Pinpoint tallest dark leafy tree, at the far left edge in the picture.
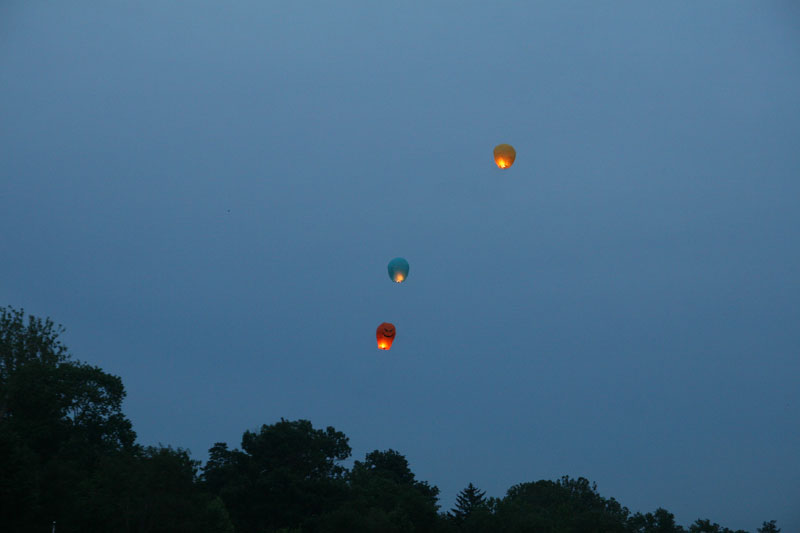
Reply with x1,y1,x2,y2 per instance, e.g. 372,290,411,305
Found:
0,307,136,530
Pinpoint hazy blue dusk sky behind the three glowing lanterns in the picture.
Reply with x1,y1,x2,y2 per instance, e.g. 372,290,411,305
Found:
0,0,800,532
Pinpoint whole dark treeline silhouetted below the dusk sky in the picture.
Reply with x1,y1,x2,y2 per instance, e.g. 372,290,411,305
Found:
0,307,780,533
